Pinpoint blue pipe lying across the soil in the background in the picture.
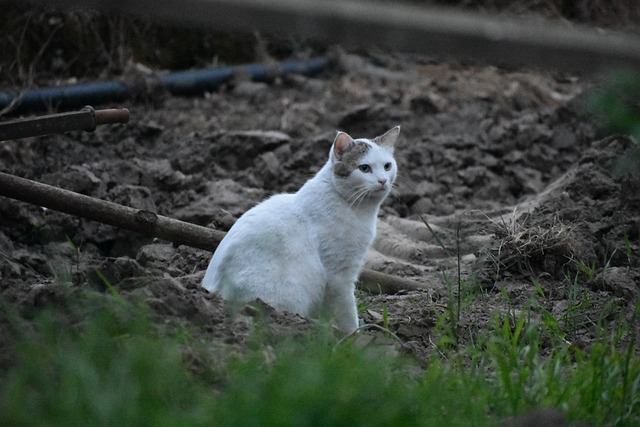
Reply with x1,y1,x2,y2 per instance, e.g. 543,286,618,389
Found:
0,58,327,114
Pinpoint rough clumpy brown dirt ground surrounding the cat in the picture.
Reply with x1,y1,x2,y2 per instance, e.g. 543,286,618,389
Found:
0,47,640,368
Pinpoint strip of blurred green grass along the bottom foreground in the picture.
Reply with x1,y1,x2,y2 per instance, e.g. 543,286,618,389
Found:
0,286,640,426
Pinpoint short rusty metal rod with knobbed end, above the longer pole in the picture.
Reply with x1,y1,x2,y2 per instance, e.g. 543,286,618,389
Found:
0,106,129,141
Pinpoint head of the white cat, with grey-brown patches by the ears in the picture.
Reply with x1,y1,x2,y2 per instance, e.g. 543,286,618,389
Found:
329,126,400,206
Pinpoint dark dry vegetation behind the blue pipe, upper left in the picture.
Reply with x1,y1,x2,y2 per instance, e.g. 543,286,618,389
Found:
0,0,300,88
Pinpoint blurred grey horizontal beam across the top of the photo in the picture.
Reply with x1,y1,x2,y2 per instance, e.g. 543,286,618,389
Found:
47,0,640,72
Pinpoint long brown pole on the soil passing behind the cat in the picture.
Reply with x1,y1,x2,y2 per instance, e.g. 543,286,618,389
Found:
0,172,425,293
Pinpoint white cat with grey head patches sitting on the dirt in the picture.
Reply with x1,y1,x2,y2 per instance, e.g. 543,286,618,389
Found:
202,126,400,332
